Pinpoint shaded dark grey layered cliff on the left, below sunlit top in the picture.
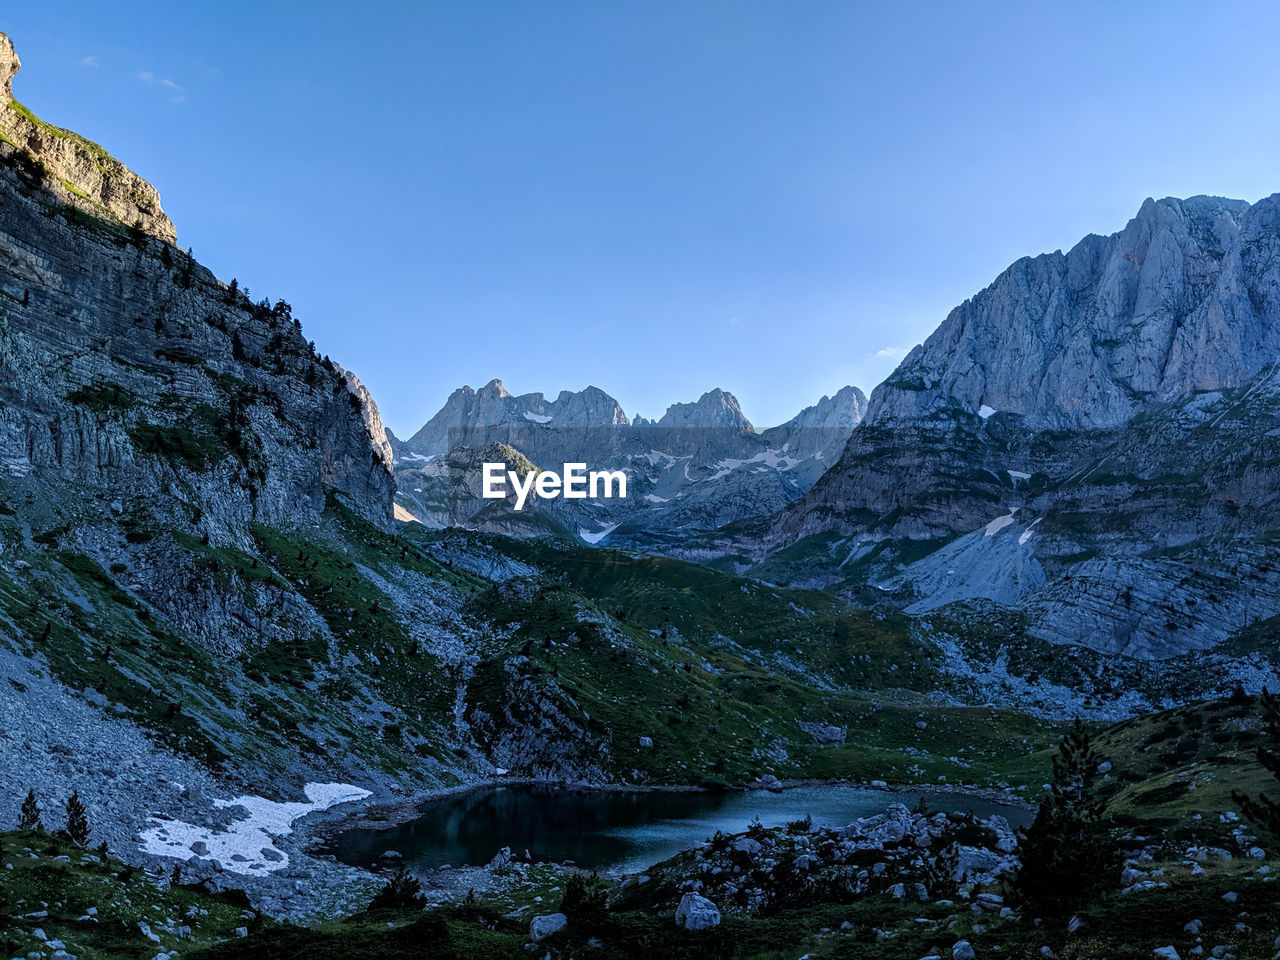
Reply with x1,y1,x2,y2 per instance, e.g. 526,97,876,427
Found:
0,135,393,541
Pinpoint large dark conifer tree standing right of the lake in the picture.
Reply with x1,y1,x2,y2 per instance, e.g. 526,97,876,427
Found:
1012,718,1120,916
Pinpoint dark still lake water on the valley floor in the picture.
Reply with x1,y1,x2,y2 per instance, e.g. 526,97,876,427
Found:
328,785,1032,873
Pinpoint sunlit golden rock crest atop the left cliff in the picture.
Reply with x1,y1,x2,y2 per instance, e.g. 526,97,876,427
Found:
0,33,178,243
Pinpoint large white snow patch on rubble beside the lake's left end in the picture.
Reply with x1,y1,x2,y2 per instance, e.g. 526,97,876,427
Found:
141,783,370,877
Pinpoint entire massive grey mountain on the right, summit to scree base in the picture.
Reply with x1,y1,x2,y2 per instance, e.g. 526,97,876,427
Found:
732,197,1280,658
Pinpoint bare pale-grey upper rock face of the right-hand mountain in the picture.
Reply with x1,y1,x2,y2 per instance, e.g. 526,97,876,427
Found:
867,197,1280,429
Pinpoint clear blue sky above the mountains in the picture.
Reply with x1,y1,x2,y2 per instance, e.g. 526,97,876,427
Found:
0,0,1280,435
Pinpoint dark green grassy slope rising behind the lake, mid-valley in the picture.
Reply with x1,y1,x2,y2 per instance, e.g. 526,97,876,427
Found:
413,534,1056,785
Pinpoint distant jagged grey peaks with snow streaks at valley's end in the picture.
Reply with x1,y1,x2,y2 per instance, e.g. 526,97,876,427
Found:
394,380,867,552
